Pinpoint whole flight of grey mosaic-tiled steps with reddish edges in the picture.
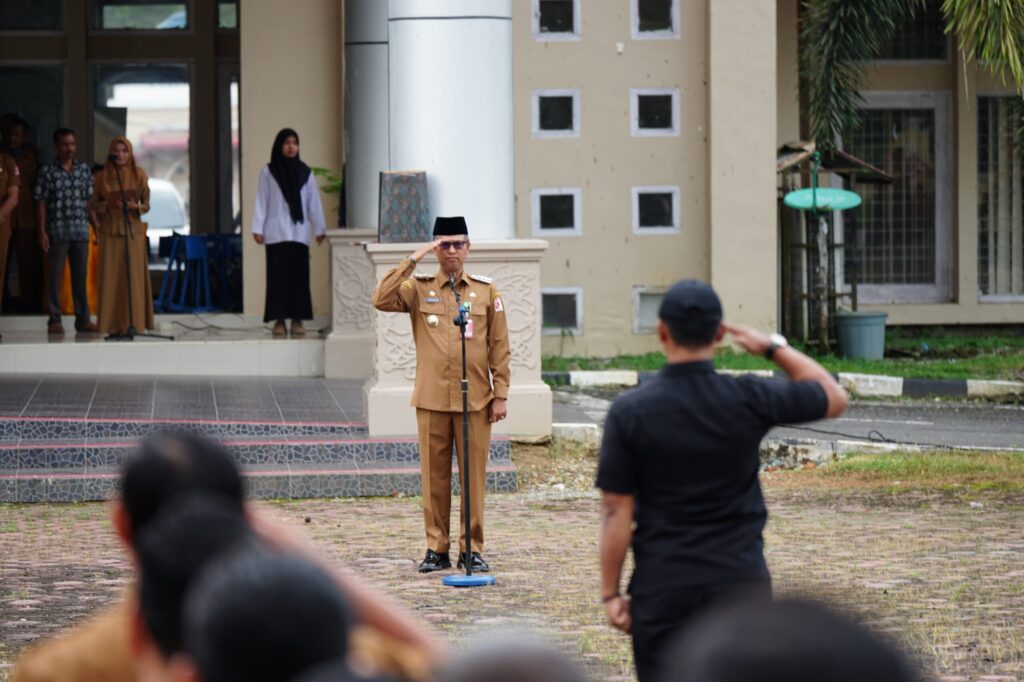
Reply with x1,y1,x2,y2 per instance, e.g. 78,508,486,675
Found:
0,417,516,503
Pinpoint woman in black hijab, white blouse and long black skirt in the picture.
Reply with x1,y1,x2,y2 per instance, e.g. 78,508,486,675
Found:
253,128,325,337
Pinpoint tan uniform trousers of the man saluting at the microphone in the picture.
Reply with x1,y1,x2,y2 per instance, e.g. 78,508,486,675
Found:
416,408,490,554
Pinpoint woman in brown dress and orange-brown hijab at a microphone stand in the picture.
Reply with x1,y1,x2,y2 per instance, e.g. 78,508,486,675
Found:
91,136,154,335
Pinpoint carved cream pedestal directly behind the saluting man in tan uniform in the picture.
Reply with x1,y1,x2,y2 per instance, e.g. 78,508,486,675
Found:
362,240,551,437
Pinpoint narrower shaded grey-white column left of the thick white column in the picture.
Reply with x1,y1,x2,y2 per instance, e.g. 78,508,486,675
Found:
345,0,390,230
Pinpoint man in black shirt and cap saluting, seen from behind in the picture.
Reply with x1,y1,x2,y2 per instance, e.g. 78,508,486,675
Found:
597,280,848,682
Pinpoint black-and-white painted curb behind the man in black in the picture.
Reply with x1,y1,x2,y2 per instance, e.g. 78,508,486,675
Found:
543,370,1024,398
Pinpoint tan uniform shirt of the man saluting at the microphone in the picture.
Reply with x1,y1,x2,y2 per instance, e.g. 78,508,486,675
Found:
374,258,511,412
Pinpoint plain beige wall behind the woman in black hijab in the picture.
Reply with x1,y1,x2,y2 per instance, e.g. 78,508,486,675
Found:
240,0,344,315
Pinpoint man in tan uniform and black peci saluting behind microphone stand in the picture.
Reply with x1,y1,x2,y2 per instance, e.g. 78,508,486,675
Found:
374,216,511,572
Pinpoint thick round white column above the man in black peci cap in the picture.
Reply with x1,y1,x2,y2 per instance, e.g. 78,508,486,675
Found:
387,0,515,238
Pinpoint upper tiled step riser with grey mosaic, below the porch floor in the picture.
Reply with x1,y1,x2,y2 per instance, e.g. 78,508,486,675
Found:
0,417,367,446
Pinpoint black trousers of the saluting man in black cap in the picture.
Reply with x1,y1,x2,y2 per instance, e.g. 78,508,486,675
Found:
630,581,771,682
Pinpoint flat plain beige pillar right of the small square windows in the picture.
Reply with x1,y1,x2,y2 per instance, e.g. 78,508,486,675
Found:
708,0,778,330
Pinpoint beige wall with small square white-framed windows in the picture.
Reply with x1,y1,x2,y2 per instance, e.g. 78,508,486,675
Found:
513,0,709,355
